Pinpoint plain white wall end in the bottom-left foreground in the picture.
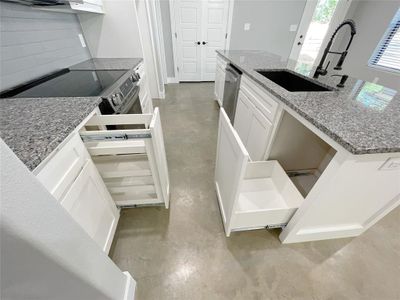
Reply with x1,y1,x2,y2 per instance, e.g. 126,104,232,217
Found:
0,139,134,300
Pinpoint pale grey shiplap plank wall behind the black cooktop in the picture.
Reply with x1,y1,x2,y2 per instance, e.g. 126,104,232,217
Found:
0,2,90,90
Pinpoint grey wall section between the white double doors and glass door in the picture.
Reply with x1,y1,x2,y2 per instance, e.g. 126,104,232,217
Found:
230,0,306,58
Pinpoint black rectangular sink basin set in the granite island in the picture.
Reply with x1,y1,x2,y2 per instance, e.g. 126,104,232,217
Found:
256,70,333,92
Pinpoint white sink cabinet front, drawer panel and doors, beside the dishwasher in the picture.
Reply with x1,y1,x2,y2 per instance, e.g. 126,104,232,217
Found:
234,76,278,160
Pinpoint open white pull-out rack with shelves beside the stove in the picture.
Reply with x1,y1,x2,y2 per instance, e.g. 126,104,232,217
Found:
80,108,169,208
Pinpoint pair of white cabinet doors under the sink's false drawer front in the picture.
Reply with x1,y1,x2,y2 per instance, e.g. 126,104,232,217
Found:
234,91,273,160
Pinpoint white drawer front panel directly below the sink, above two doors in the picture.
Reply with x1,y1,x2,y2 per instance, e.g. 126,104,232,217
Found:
240,75,279,123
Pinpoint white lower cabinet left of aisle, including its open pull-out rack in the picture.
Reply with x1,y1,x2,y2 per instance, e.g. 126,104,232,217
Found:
34,108,170,253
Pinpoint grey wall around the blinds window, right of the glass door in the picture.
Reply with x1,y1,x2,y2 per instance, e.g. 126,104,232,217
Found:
341,0,400,89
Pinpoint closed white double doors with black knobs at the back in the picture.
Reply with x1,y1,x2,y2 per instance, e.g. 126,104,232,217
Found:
170,0,230,81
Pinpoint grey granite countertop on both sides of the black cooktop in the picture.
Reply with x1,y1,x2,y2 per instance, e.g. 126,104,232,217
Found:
0,58,142,171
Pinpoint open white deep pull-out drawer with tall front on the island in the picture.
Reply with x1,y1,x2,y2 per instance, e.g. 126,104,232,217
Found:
215,108,304,236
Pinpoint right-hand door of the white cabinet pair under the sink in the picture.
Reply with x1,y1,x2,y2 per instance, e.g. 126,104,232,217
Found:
245,107,272,161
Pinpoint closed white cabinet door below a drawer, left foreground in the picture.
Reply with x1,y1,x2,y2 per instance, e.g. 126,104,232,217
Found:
61,160,119,252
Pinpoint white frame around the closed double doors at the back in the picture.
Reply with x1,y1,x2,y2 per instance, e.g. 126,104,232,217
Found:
168,0,235,83
